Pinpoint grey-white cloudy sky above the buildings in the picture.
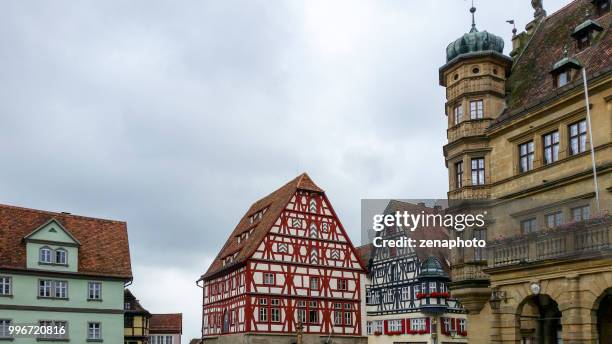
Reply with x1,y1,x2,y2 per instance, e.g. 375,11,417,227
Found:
0,0,568,338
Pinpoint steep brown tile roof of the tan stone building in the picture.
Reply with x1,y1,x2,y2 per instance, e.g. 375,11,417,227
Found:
497,0,612,122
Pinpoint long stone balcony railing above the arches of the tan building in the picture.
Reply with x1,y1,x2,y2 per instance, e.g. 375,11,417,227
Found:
488,216,612,268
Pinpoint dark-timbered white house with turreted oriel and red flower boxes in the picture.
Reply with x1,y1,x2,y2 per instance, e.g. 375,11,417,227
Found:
358,200,467,344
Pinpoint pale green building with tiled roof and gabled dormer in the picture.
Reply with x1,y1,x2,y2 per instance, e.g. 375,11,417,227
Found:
0,205,132,344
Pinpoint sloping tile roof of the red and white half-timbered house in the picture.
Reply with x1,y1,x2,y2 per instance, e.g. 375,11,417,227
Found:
202,173,324,279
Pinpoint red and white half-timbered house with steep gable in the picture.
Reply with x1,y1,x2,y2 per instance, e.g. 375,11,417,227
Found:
198,174,366,343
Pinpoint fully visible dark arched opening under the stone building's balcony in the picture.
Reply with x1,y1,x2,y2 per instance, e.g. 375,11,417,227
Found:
517,294,562,344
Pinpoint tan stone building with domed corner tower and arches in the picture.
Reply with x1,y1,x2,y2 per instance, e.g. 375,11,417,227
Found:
440,0,612,343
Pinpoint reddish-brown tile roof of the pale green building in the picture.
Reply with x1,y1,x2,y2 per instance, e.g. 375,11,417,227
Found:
0,205,132,280
